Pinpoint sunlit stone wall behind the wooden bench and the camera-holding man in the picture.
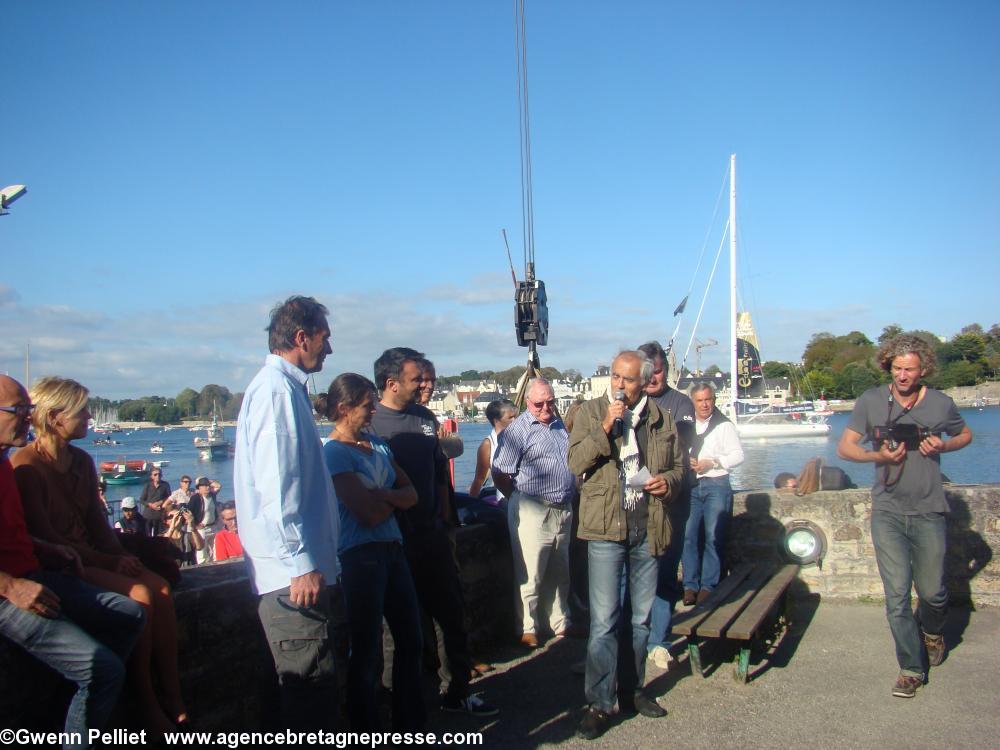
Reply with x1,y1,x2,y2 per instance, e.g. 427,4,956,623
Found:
727,485,1000,606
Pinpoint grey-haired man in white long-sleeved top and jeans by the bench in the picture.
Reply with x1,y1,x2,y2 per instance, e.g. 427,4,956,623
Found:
681,383,743,605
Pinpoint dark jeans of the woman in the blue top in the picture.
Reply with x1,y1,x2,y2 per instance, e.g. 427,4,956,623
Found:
340,542,427,732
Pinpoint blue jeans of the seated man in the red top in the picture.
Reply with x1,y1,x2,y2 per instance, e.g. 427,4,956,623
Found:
0,570,145,748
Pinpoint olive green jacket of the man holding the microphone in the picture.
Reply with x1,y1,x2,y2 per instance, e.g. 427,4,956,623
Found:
569,396,683,555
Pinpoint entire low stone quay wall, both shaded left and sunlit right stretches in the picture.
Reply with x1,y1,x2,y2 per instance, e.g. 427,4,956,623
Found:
0,485,1000,731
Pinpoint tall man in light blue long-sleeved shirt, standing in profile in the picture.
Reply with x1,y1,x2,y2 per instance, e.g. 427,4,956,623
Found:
233,297,339,731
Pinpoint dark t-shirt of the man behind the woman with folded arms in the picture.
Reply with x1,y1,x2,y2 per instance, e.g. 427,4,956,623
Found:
372,403,448,537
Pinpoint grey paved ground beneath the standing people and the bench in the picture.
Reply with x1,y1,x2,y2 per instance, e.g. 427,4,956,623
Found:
429,598,1000,750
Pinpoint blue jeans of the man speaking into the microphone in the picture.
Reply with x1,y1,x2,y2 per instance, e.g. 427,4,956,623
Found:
585,534,656,711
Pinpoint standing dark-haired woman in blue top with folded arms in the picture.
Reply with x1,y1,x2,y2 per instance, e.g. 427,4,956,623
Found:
316,373,427,732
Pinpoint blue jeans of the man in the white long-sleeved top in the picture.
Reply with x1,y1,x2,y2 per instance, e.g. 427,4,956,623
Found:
681,475,733,591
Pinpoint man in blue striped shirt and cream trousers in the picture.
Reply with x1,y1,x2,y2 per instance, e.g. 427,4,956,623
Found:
493,378,576,648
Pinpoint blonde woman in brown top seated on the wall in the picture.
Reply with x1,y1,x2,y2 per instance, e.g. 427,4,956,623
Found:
11,378,187,732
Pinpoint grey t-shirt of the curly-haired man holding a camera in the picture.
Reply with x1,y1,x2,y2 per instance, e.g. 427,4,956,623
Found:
847,385,965,516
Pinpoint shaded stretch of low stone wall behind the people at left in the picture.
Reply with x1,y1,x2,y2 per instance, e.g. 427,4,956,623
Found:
0,525,514,731
